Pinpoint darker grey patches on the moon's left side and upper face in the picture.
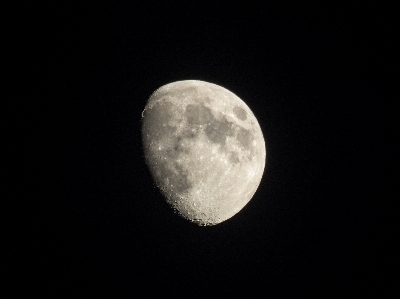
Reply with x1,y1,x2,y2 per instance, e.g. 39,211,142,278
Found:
142,81,264,224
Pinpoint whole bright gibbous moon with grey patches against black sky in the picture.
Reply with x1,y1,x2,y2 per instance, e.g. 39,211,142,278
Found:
141,80,266,226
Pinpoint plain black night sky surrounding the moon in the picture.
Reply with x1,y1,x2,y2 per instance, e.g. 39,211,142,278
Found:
9,1,399,298
